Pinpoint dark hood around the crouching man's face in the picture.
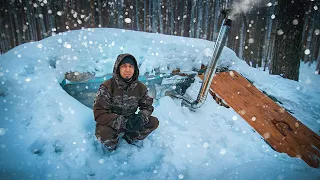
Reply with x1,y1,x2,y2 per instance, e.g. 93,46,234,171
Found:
113,54,139,89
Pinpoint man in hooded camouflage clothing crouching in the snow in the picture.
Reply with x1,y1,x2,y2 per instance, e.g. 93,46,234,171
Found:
93,54,159,150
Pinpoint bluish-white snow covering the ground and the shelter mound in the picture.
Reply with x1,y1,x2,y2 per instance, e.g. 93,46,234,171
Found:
0,29,320,179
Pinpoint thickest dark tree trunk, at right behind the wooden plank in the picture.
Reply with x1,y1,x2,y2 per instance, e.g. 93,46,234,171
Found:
270,0,305,81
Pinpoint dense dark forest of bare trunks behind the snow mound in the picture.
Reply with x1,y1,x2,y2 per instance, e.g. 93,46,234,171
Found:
0,0,320,80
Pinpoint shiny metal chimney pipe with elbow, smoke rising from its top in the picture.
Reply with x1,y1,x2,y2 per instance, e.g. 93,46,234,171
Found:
178,19,232,109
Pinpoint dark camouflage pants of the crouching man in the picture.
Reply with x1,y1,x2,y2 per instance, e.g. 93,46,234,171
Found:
95,116,159,150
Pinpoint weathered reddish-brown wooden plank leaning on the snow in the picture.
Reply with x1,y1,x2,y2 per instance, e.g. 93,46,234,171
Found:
199,71,320,168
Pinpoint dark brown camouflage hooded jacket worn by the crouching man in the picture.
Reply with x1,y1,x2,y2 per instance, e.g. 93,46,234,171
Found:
93,54,154,129
